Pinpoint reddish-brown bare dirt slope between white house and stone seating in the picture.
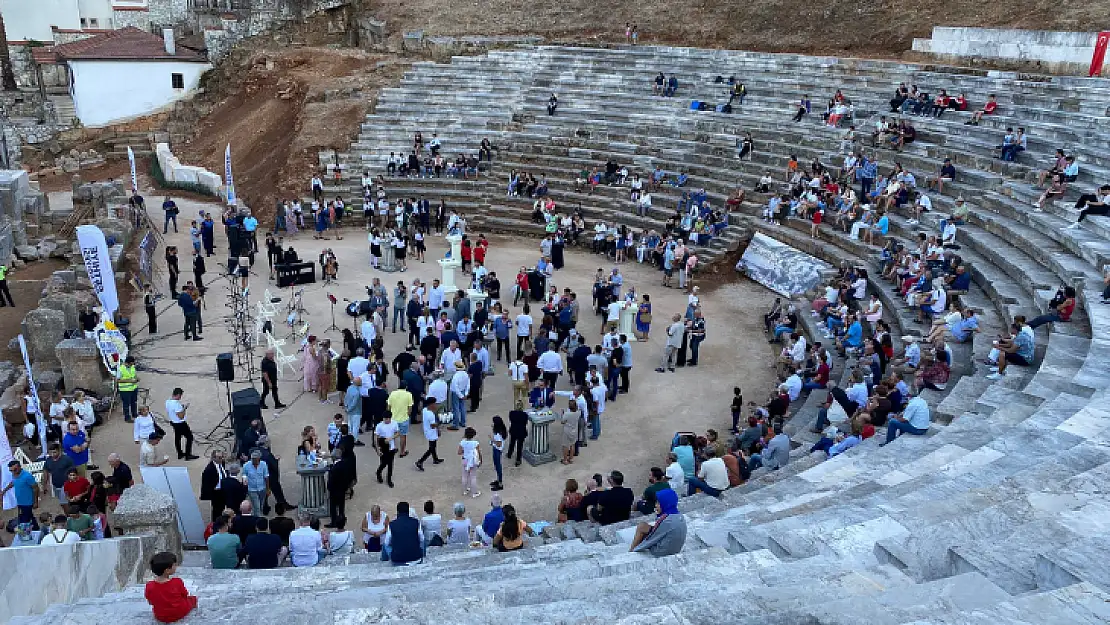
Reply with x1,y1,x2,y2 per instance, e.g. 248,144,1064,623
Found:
170,38,406,215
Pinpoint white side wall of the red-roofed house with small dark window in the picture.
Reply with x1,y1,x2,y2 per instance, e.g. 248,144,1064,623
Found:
69,61,212,127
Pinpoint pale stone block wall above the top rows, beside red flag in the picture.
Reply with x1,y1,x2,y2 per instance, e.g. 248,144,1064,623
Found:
912,27,1110,74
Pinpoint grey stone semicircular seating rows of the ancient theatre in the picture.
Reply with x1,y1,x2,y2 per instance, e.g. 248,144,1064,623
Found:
16,47,1110,625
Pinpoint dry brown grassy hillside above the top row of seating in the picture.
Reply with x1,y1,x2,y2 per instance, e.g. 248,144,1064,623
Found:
367,0,1110,58
